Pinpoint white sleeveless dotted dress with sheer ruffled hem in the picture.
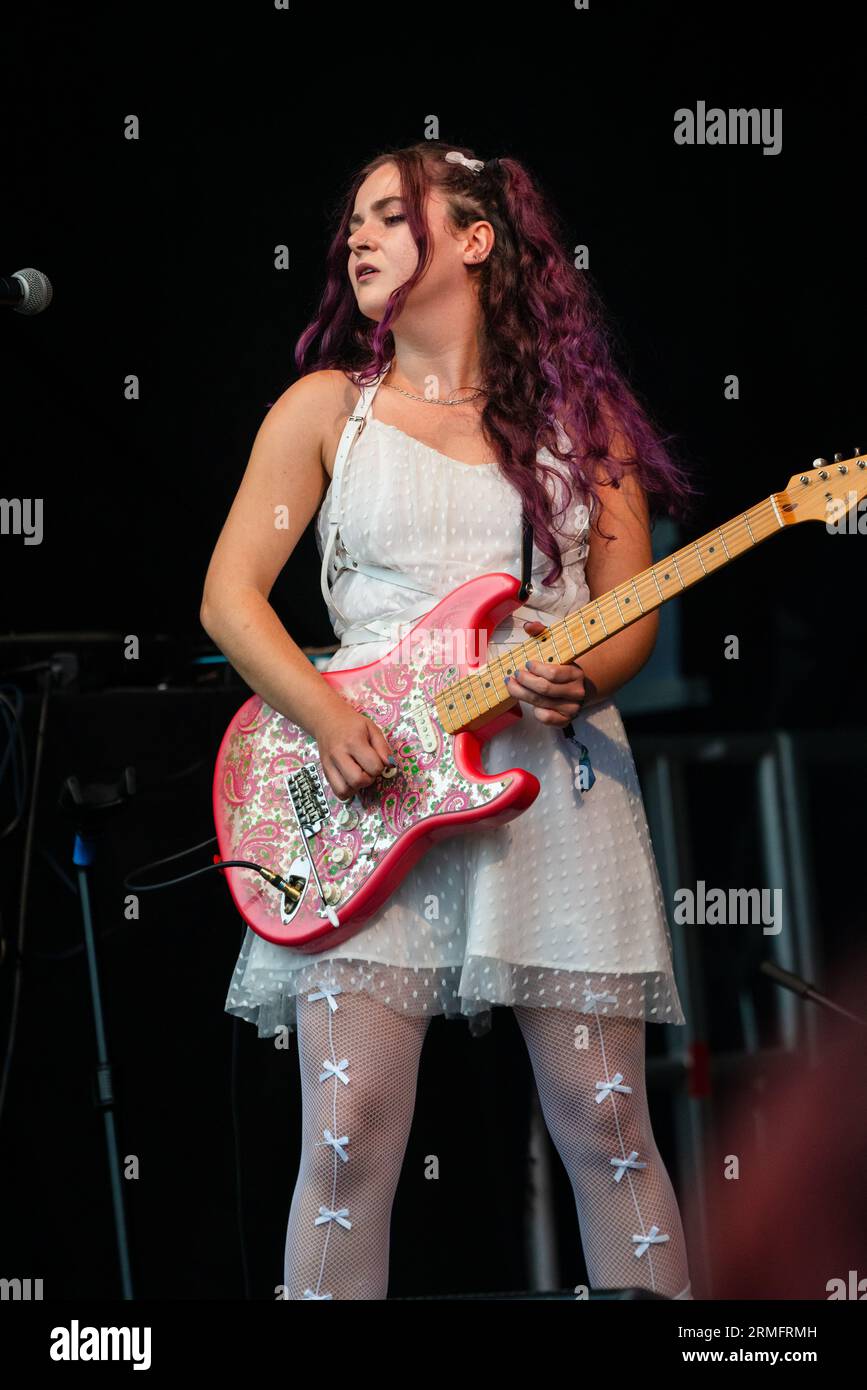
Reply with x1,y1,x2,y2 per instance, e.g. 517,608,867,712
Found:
225,375,686,1037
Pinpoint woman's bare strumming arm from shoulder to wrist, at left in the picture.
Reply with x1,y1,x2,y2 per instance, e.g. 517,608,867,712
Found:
199,373,352,737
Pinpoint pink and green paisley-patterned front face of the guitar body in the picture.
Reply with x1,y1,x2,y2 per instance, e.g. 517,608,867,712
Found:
214,647,513,926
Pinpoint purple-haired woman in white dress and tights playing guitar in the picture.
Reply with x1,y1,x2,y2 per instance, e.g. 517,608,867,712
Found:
201,140,692,1300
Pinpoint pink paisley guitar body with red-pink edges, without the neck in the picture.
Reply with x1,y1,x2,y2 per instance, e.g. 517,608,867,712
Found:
214,574,540,954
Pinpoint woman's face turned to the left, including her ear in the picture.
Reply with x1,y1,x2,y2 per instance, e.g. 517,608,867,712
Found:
347,164,480,322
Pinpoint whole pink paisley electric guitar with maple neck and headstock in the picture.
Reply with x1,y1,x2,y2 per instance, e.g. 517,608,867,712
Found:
214,455,867,954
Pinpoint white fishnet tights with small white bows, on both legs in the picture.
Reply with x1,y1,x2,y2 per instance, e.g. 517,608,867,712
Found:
283,981,691,1300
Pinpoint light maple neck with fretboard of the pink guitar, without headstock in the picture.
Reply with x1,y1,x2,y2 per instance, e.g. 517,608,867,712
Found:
435,495,785,734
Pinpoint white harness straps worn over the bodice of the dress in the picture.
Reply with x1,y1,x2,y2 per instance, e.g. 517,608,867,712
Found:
320,364,539,646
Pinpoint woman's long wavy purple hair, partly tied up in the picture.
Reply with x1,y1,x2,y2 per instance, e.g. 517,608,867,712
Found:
295,140,696,584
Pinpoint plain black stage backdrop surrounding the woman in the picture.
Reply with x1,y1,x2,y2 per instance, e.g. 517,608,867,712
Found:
0,3,867,1298
